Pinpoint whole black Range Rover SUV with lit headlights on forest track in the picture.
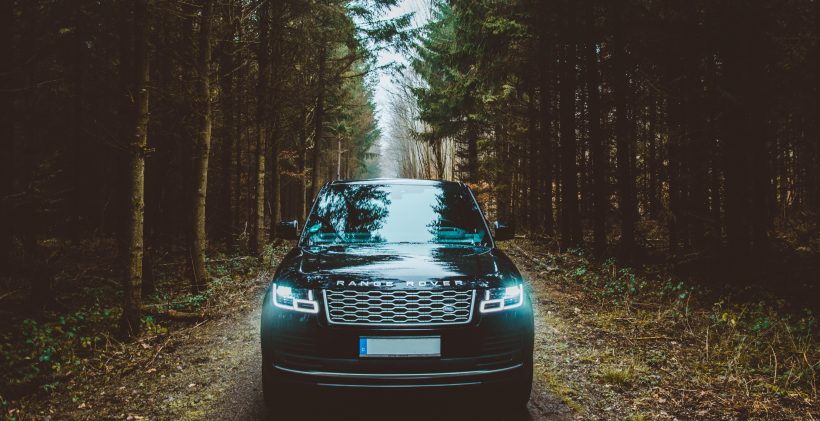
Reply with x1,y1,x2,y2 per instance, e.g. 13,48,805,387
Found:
261,179,533,408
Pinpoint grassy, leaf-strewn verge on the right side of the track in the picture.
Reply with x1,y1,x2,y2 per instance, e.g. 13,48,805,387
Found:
504,239,820,419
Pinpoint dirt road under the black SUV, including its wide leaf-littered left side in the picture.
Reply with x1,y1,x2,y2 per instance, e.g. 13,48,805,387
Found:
22,248,575,421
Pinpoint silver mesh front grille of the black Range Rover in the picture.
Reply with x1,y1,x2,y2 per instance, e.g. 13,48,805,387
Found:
324,290,475,326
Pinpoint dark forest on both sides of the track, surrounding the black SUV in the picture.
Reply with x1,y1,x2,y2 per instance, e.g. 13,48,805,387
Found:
0,0,820,419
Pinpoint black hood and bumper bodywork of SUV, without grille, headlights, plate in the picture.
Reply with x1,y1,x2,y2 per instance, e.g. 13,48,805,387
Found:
261,178,534,400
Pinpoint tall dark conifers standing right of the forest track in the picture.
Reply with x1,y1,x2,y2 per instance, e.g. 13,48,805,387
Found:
404,0,820,260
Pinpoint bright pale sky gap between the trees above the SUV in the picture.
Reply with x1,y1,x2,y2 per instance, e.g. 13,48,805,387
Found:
374,0,431,177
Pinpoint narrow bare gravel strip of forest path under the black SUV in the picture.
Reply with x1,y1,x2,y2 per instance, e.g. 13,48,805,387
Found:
193,251,573,421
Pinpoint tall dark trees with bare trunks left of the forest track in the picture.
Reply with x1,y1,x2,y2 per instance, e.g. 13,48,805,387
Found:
0,0,408,333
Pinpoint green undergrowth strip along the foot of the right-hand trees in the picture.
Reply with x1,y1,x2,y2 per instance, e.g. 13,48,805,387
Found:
556,244,820,412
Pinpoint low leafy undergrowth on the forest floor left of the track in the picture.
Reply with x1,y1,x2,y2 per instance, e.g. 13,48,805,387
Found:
0,241,289,420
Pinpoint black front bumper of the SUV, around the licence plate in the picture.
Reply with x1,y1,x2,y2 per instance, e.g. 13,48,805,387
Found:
261,290,533,388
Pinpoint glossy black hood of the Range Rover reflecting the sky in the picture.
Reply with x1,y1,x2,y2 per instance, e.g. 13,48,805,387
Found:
277,244,520,289
